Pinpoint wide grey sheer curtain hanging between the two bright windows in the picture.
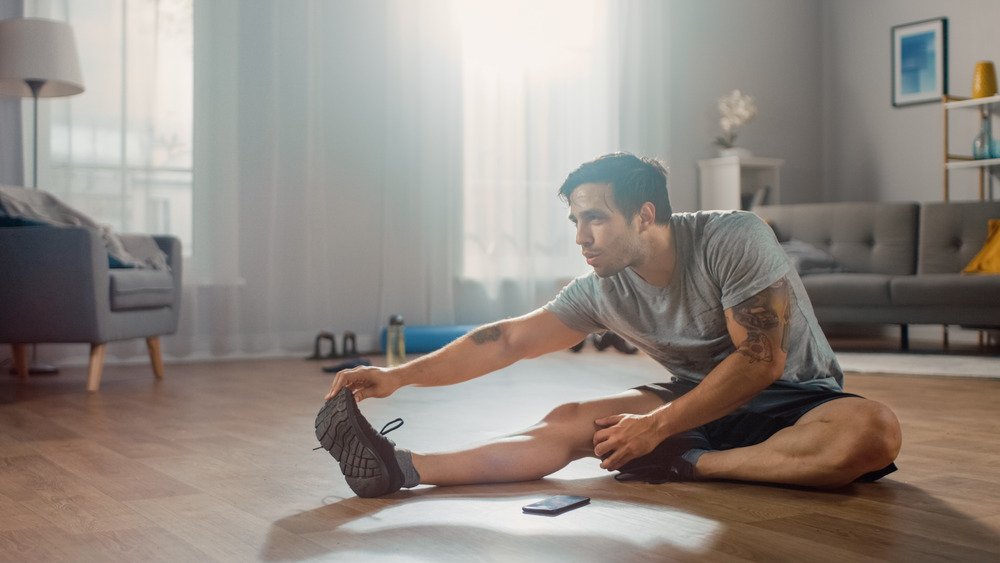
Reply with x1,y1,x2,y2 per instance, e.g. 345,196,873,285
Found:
174,0,461,357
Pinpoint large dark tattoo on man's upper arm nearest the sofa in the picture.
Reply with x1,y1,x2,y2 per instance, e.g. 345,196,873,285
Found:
733,278,793,363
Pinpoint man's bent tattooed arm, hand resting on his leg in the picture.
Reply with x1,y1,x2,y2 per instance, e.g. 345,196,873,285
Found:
594,278,794,470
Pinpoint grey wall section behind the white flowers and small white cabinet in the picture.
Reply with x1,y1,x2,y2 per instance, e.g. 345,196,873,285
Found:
669,0,829,211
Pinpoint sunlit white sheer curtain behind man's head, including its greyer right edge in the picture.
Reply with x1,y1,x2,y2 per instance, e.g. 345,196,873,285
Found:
454,0,668,320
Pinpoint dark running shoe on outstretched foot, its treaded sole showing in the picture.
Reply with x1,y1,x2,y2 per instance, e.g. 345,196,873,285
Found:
316,388,403,497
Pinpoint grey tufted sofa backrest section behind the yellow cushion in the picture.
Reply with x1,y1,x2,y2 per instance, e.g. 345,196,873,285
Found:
917,201,1000,274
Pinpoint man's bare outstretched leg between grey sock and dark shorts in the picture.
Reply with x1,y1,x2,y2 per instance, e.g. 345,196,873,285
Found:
413,389,663,485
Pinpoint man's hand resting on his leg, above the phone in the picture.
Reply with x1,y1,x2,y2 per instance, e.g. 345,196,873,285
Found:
594,414,663,471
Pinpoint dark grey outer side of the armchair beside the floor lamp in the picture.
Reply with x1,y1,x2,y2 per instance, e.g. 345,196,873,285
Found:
0,226,110,343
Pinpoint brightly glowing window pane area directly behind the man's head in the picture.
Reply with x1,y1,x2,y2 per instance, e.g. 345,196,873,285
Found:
455,0,619,288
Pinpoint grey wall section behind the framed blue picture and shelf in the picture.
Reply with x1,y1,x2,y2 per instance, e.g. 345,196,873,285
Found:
820,0,1000,201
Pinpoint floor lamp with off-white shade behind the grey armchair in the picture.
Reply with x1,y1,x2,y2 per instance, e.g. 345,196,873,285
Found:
0,18,83,374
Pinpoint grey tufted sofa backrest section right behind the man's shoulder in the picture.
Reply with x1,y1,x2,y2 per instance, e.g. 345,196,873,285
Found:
753,202,918,275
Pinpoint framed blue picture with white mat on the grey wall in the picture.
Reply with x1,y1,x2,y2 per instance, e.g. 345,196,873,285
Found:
892,18,948,107
